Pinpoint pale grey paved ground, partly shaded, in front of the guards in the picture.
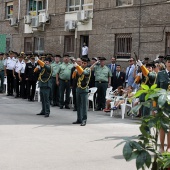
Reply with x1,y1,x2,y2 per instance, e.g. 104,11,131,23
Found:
0,94,138,170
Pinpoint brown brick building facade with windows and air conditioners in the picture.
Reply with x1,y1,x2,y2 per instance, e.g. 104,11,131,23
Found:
0,0,170,61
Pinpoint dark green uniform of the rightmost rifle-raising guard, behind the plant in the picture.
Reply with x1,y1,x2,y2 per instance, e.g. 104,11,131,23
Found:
139,72,156,116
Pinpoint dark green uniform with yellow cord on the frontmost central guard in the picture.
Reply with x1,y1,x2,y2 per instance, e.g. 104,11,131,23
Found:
76,68,91,123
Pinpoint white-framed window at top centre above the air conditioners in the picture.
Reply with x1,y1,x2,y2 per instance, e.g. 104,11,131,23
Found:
67,0,93,12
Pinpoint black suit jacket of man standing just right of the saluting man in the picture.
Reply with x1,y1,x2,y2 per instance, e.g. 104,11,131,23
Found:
111,72,125,90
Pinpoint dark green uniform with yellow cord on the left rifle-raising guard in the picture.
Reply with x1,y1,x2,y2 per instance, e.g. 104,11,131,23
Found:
38,65,52,116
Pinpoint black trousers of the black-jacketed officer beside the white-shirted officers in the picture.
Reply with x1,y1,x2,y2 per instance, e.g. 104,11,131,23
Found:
27,80,36,100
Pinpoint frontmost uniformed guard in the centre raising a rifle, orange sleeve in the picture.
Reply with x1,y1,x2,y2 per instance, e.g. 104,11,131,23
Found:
73,58,91,126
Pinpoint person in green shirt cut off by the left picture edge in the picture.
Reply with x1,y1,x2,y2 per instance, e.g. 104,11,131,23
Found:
0,53,4,93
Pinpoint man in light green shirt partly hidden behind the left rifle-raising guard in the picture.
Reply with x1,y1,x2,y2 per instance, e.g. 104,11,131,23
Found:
51,55,61,107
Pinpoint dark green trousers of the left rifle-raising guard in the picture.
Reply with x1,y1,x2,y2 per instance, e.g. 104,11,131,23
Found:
40,87,51,115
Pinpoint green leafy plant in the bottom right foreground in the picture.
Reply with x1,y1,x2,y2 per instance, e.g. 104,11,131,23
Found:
116,84,170,170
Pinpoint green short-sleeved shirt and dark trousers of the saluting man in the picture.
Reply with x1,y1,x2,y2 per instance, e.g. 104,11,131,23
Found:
94,65,112,110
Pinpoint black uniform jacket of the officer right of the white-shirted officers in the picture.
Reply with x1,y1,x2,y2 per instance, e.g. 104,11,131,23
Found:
25,62,38,81
